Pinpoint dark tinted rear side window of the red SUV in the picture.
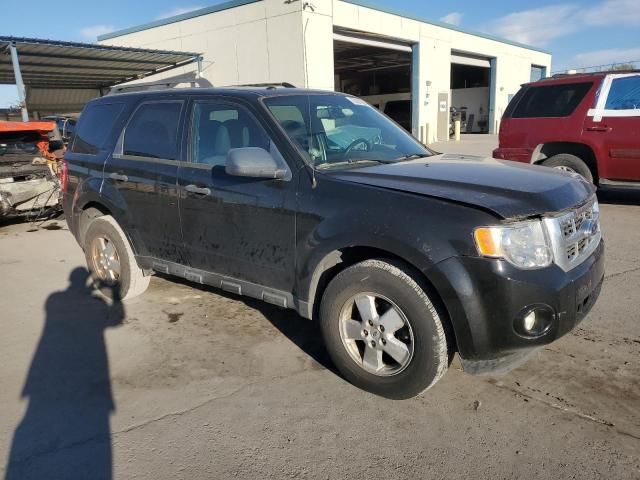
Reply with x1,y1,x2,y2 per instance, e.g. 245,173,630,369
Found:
511,82,593,118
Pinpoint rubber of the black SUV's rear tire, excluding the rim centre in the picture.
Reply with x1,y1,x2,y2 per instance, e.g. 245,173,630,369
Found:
84,215,151,300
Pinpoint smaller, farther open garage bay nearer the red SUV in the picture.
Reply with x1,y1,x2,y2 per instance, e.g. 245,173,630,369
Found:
451,53,491,133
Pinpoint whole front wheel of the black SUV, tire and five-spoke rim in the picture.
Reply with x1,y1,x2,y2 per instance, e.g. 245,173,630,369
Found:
320,260,449,399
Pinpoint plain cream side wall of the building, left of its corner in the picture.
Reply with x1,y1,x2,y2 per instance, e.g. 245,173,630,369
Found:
100,0,308,85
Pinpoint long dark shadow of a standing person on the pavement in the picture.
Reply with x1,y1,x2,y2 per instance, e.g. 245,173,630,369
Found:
5,268,125,480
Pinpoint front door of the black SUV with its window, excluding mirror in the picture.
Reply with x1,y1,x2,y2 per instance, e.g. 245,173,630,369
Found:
178,99,296,292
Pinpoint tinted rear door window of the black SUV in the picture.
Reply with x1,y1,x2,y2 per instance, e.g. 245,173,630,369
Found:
122,101,182,160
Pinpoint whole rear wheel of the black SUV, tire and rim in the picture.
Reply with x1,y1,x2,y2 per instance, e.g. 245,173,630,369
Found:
84,215,151,300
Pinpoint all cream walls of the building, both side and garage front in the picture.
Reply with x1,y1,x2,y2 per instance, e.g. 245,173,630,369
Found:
101,0,551,143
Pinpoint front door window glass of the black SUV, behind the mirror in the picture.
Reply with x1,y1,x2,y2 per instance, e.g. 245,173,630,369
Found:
191,102,270,166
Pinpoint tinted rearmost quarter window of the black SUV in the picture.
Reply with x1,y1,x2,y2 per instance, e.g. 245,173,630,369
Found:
71,103,124,155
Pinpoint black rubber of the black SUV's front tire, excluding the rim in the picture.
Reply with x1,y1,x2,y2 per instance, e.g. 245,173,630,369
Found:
320,259,449,399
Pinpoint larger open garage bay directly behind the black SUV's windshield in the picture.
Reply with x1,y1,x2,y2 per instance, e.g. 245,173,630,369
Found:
333,33,413,132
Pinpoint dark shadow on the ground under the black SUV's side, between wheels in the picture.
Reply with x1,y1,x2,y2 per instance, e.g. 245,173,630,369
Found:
161,274,339,376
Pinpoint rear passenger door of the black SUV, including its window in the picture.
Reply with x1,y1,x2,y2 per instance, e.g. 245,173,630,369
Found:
103,96,186,263
